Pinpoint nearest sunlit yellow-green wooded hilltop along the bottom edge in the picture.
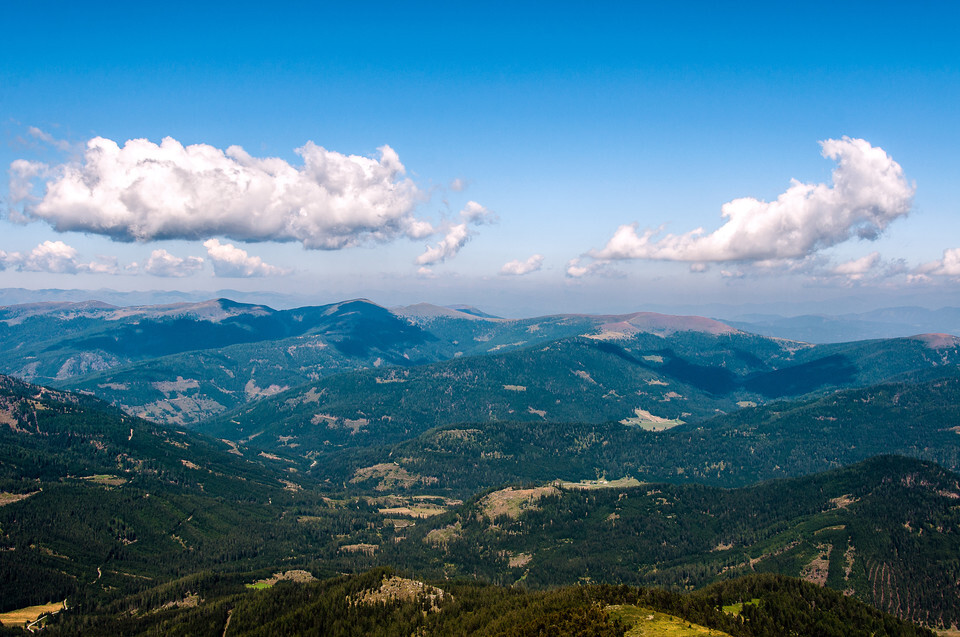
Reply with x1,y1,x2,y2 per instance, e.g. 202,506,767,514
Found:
35,569,934,637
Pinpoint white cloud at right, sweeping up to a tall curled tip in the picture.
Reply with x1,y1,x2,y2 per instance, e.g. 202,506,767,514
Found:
588,137,915,263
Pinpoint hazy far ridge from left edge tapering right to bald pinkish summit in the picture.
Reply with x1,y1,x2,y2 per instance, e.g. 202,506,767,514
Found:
0,299,756,423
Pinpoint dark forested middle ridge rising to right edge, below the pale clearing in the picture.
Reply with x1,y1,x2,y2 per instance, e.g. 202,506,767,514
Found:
324,370,960,497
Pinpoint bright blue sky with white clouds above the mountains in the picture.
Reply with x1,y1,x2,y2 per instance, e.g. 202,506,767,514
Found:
0,2,960,314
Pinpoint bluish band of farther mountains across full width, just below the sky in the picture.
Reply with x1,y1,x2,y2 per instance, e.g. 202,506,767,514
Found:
0,298,960,433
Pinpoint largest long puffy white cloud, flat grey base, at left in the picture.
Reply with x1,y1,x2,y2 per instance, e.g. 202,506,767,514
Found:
10,131,432,250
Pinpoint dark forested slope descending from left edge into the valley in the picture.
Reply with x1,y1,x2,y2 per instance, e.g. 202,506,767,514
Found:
0,377,358,612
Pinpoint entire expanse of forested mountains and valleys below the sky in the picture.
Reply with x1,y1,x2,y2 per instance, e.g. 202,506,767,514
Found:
0,299,960,635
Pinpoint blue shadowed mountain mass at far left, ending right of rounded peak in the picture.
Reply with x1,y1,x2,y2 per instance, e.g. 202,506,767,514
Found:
0,299,446,424
